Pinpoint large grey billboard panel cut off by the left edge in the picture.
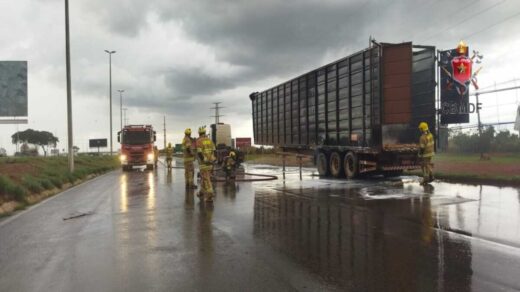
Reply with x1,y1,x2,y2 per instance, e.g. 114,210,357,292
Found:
0,61,27,118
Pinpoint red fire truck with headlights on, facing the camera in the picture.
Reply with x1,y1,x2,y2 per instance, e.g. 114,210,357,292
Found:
117,125,156,171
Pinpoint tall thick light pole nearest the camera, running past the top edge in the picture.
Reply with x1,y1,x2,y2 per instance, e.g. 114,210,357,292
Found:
65,0,74,172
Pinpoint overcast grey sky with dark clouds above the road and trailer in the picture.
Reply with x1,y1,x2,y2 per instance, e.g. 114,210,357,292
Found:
0,0,520,152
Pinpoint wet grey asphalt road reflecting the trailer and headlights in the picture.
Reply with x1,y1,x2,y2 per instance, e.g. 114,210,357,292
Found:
0,159,520,291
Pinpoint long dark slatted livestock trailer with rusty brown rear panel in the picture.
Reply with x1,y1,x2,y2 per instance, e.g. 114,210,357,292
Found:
249,41,436,178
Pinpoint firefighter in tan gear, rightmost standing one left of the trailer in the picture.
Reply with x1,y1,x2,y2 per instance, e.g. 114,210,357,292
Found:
197,127,215,202
